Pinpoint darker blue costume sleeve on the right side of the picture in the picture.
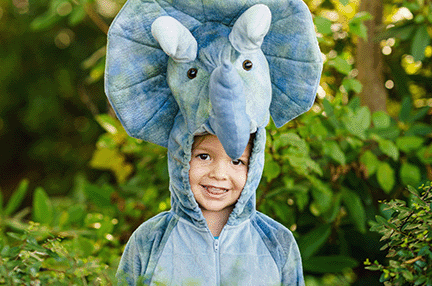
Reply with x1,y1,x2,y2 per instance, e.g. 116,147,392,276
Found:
251,212,304,285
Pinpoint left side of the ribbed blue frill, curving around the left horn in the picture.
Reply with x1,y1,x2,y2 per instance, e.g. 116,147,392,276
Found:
105,1,199,147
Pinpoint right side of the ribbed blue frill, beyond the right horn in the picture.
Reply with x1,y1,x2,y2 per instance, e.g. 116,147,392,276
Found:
261,0,323,127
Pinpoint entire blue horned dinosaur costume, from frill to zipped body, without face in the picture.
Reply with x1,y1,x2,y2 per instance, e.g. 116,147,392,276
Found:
105,0,322,285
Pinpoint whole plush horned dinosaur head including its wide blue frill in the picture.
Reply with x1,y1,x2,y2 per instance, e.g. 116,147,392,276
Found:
105,0,322,158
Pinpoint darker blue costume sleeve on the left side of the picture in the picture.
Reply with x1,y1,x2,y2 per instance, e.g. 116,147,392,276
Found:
116,212,178,285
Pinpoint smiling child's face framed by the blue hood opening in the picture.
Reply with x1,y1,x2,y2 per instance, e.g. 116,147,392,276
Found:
189,135,251,212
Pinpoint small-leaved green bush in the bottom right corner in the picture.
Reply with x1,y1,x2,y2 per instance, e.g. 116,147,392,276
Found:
365,183,432,285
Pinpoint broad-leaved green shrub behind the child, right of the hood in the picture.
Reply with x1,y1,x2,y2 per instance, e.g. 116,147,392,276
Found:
258,96,432,280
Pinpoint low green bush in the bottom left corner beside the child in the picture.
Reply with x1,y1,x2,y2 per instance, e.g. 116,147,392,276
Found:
0,178,125,285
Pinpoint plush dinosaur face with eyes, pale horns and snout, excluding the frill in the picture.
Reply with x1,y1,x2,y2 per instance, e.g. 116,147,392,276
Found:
152,4,272,159
